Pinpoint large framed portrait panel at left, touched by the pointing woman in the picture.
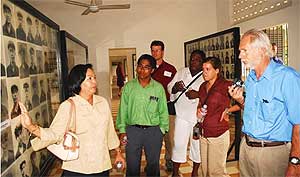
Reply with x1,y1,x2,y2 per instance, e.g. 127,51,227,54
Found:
1,0,62,176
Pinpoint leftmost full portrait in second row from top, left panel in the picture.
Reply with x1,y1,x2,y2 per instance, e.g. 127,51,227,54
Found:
6,41,19,77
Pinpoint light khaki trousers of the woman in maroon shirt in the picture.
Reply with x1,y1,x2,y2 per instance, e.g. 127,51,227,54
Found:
200,130,230,177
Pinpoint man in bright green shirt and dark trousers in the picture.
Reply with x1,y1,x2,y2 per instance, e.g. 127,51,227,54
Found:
117,54,169,176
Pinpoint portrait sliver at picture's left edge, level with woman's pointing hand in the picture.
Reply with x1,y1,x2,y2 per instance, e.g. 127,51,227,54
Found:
0,79,9,122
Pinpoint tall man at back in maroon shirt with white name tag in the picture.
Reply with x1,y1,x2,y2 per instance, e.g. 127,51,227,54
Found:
150,40,177,171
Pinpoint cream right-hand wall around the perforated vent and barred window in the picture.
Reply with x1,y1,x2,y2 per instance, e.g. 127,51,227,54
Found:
217,0,300,71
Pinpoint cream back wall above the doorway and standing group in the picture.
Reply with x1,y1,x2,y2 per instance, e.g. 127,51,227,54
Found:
91,0,216,100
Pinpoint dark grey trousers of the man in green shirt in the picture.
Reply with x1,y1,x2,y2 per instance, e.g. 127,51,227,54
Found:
126,126,163,176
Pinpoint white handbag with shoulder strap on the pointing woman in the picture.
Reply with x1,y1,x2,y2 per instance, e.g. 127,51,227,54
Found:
47,98,79,161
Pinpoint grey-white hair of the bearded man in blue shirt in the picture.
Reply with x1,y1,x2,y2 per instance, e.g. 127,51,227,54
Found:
242,29,273,57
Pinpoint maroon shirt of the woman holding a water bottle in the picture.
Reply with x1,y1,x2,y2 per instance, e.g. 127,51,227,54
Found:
199,77,232,137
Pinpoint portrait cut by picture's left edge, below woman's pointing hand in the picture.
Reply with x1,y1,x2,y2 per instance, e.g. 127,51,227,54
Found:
1,126,14,172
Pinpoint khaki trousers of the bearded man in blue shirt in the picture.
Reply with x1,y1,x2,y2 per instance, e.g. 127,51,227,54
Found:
239,137,291,177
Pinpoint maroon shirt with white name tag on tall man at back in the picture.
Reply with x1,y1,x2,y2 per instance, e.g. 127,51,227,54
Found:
152,61,177,101
